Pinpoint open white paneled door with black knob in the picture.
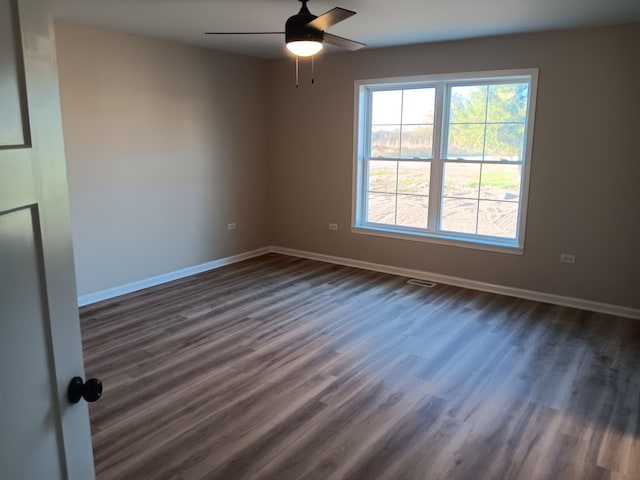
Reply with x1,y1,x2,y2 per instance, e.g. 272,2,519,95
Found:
0,0,95,480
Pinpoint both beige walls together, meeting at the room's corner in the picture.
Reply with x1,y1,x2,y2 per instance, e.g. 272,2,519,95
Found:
57,24,640,308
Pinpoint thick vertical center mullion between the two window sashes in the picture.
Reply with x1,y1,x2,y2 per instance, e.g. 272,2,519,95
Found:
427,83,447,232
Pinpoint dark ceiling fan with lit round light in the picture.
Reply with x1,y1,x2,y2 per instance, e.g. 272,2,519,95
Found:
205,0,366,57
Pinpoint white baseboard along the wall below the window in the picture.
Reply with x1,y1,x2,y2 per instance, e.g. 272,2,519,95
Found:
270,246,640,319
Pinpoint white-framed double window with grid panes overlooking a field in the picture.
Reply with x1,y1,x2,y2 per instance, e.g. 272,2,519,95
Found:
353,70,537,253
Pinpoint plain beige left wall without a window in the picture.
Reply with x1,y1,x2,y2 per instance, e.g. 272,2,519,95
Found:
56,24,269,295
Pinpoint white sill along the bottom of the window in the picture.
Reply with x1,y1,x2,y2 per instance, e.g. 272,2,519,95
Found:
351,225,524,255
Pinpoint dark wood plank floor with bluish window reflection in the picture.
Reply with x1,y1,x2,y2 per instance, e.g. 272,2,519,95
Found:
81,254,640,480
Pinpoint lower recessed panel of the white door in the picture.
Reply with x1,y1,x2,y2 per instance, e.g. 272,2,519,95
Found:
0,208,63,480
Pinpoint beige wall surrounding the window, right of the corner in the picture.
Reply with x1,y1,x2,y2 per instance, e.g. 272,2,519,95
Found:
269,24,640,308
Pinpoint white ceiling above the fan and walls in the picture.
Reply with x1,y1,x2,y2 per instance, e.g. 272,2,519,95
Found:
53,0,640,58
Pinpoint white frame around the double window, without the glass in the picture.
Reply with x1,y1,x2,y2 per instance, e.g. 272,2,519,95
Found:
351,68,538,255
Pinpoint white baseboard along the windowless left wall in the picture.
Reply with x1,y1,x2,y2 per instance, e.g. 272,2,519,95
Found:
78,247,272,307
